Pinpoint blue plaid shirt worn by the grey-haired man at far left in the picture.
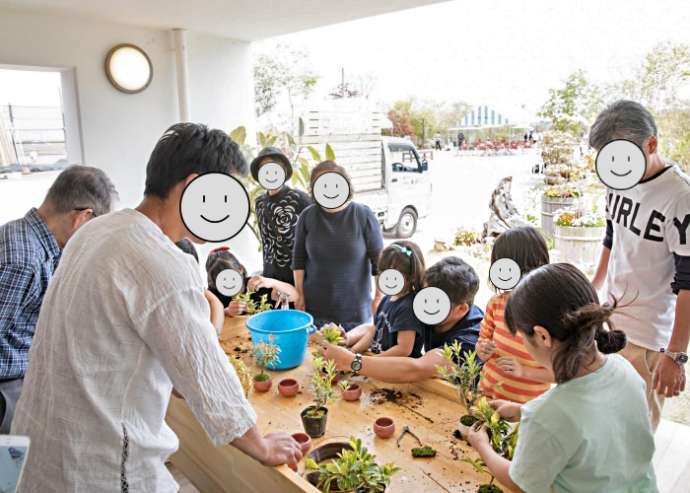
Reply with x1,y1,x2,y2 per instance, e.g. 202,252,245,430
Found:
0,208,60,380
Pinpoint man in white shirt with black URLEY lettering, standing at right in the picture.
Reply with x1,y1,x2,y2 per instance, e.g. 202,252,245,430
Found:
589,101,690,429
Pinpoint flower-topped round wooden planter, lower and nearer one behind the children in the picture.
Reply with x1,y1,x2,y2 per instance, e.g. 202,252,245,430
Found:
554,208,606,271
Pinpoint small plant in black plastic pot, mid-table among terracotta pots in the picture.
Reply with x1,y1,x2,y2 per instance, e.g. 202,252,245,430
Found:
301,356,348,438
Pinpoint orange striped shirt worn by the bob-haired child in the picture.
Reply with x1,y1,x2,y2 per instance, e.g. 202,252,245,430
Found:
479,293,551,403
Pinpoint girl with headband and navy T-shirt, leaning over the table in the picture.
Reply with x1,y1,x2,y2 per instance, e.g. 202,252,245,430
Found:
345,241,425,358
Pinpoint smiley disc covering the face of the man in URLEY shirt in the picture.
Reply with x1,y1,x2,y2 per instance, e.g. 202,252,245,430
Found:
596,139,647,190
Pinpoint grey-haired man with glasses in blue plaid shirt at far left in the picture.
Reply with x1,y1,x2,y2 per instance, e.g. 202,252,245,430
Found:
0,166,117,433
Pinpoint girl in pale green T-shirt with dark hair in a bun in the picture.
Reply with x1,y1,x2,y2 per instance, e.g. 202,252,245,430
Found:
465,264,658,493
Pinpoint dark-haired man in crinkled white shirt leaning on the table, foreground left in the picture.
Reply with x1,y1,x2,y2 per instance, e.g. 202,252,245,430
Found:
12,123,301,493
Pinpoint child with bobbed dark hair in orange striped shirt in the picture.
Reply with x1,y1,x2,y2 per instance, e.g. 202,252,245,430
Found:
477,226,553,402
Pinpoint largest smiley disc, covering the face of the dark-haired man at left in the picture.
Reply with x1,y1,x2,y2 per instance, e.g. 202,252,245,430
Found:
180,173,249,242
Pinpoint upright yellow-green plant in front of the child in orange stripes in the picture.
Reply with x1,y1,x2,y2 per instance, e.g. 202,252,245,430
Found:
436,341,482,410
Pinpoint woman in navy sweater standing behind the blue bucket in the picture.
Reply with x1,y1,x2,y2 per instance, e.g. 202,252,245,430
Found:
292,161,383,330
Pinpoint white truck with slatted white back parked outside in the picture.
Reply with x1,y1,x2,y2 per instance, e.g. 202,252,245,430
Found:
302,105,431,238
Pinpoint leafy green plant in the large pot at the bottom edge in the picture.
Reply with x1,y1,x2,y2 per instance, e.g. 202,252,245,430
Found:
305,437,400,493
